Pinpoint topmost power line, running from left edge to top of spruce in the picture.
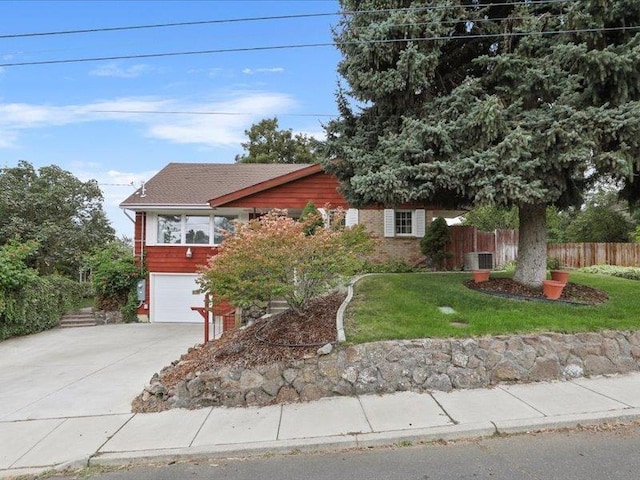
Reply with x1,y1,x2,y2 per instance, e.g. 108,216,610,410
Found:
0,0,573,39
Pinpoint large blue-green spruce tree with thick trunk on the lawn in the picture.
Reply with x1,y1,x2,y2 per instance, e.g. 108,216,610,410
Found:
327,0,640,286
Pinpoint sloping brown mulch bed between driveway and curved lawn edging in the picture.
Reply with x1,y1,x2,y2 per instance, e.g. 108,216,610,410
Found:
160,293,346,388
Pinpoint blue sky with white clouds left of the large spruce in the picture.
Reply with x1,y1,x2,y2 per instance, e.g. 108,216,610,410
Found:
0,0,340,236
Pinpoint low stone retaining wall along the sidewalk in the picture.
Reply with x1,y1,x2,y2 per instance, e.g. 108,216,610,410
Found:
134,331,640,411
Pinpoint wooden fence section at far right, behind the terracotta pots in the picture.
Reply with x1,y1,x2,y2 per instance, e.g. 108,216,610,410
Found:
547,243,640,268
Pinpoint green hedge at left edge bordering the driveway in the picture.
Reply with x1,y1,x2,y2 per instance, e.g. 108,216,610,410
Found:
0,242,82,340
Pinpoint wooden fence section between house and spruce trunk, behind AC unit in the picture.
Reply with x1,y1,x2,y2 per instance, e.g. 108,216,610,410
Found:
446,225,518,269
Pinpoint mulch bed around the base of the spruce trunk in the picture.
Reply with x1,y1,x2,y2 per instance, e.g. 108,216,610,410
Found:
465,278,609,305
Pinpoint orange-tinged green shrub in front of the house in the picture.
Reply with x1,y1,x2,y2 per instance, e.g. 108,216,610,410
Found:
201,211,373,311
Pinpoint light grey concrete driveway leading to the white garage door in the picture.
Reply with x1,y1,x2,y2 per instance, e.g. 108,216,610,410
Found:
0,324,202,422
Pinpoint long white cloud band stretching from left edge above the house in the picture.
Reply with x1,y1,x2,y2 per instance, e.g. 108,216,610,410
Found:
0,92,296,148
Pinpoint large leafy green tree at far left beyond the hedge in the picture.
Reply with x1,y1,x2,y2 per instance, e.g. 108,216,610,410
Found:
0,161,114,278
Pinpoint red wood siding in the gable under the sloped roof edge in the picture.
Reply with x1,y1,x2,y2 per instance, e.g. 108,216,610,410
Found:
224,172,348,208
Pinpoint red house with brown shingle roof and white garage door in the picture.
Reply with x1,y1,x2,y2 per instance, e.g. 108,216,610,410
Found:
120,163,459,322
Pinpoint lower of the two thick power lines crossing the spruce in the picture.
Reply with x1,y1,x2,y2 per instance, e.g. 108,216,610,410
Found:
0,26,640,67
